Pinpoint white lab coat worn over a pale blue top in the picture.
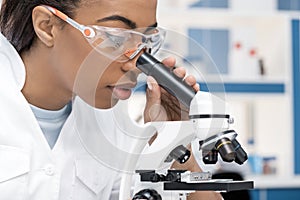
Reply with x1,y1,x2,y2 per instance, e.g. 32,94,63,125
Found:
0,35,139,200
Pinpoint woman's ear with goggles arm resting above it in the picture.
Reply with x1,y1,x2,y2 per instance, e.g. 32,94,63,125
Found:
32,6,57,47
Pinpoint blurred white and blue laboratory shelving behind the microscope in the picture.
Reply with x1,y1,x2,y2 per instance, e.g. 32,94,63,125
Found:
132,0,300,200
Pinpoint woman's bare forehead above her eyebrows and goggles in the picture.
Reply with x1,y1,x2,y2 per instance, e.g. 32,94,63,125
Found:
75,0,157,27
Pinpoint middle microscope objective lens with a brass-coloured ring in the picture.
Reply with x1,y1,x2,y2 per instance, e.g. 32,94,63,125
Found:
215,138,236,162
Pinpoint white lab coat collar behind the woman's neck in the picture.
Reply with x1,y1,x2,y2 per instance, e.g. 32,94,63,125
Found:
0,33,26,91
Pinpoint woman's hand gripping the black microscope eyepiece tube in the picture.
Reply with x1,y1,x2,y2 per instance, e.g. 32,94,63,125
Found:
144,58,199,122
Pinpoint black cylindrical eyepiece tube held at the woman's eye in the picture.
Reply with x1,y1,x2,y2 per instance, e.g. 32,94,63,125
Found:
136,52,196,108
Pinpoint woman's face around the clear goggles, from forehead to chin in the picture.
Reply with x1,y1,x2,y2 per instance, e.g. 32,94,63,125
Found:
51,0,157,108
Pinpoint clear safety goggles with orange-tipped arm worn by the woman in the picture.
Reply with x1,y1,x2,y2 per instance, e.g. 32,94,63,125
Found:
44,5,166,62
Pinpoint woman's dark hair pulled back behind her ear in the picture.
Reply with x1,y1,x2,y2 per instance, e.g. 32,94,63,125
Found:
0,0,80,53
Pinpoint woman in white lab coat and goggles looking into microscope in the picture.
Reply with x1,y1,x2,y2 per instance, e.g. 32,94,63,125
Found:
0,0,220,200
